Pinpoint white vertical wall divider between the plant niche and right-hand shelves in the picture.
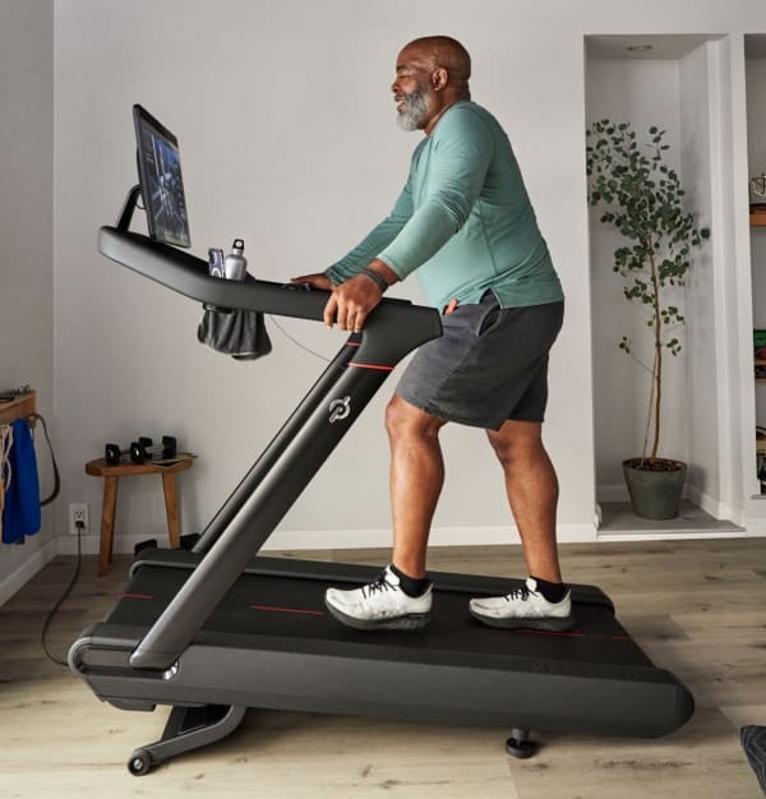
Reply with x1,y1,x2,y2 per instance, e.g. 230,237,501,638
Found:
684,39,755,532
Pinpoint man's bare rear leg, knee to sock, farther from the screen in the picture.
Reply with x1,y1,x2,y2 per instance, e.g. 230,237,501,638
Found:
487,420,561,583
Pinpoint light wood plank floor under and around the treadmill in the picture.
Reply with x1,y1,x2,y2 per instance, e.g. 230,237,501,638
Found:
0,539,766,799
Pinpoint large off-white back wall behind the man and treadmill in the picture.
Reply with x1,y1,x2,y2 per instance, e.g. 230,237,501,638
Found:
54,0,766,546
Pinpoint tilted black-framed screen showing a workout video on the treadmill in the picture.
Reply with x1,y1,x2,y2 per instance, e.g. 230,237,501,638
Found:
133,105,191,247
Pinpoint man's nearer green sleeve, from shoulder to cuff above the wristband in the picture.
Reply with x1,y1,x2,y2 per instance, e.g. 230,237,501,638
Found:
377,108,494,280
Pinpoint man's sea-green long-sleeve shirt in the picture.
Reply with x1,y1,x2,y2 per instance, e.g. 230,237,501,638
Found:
326,100,564,309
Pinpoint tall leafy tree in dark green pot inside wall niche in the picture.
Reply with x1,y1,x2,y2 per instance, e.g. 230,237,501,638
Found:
586,119,710,519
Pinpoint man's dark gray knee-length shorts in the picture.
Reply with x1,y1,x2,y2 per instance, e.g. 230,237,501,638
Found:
396,291,564,430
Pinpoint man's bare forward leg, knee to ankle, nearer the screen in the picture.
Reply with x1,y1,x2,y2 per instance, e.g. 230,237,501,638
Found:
386,394,446,579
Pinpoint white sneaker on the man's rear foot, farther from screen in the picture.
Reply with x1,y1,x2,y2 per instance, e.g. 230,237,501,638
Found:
468,577,575,632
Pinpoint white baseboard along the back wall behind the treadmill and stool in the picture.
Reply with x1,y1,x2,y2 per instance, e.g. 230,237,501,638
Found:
56,524,596,555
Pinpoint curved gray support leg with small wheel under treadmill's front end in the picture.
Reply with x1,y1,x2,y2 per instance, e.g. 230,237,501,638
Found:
128,705,247,777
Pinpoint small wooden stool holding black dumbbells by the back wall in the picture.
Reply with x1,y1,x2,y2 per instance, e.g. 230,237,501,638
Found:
85,458,194,575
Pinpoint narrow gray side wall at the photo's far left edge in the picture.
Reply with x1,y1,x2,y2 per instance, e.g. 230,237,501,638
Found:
0,0,53,604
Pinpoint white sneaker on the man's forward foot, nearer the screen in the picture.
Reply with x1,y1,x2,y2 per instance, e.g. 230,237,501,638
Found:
324,566,433,630
